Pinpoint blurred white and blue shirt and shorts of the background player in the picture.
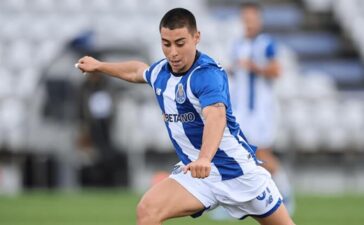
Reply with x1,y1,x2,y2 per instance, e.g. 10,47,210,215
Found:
231,34,277,148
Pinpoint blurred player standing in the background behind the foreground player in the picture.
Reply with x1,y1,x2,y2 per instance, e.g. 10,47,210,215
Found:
231,2,294,213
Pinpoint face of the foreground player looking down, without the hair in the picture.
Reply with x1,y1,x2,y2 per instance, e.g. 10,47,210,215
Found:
161,27,200,73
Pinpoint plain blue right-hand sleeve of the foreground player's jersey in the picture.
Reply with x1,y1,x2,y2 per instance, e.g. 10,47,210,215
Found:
190,67,229,108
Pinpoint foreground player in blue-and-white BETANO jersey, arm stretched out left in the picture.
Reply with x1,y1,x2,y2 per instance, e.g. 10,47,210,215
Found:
78,8,293,225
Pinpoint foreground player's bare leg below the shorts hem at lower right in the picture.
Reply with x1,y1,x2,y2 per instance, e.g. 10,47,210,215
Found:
253,204,294,225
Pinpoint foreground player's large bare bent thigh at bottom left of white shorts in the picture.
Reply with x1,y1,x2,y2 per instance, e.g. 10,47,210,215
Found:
137,178,205,225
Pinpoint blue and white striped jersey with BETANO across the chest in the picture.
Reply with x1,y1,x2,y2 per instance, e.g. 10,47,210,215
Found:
144,52,255,180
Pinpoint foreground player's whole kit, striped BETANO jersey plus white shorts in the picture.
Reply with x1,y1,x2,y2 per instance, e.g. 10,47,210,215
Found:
144,52,281,218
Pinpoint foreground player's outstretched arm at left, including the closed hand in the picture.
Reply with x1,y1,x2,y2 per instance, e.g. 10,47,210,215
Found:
76,56,149,83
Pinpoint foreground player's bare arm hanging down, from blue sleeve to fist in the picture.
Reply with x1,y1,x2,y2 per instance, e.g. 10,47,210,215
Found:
184,103,226,178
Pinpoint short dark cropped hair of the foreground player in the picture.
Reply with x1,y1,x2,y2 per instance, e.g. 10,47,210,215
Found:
159,8,197,34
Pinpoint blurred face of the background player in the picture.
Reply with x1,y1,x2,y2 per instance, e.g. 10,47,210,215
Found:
241,7,262,38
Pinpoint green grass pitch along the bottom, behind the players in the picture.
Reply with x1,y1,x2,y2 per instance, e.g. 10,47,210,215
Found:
0,190,364,225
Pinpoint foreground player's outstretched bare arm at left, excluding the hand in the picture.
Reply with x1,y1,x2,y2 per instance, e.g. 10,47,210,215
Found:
97,61,148,83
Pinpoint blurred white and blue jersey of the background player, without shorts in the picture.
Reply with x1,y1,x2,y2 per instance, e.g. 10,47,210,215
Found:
231,34,277,121
